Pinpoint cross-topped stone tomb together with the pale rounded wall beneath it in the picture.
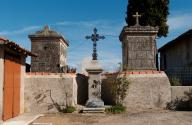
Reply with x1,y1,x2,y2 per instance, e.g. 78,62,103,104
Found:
119,13,171,109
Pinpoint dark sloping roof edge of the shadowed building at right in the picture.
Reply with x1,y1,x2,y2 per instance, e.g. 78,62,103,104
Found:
158,29,192,52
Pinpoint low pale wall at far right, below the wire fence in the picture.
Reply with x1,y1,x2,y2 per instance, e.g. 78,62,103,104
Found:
171,86,192,101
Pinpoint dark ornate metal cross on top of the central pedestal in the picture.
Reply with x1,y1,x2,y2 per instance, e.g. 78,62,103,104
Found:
85,28,105,60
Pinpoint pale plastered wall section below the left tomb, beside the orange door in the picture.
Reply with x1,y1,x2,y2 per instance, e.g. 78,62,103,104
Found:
24,73,77,113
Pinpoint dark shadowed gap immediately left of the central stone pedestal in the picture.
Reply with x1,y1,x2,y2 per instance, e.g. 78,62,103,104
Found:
76,73,88,105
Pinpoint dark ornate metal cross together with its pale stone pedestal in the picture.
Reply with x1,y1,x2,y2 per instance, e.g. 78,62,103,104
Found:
83,28,105,113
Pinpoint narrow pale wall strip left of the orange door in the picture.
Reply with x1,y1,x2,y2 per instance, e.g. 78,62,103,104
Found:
0,47,4,121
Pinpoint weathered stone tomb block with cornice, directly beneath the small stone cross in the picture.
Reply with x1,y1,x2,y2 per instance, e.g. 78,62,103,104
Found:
119,25,159,71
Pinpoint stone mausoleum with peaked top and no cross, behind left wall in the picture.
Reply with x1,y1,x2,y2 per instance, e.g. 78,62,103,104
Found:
29,26,69,73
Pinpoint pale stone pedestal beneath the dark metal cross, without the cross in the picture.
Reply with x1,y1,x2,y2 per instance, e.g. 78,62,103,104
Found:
84,60,104,112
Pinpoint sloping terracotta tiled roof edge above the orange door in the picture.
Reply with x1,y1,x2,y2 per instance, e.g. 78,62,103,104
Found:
0,37,37,56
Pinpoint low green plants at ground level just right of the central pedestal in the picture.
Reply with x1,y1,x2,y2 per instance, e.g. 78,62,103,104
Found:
105,104,126,114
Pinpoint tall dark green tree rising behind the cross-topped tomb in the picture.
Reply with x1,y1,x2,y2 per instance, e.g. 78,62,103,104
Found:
126,0,169,37
